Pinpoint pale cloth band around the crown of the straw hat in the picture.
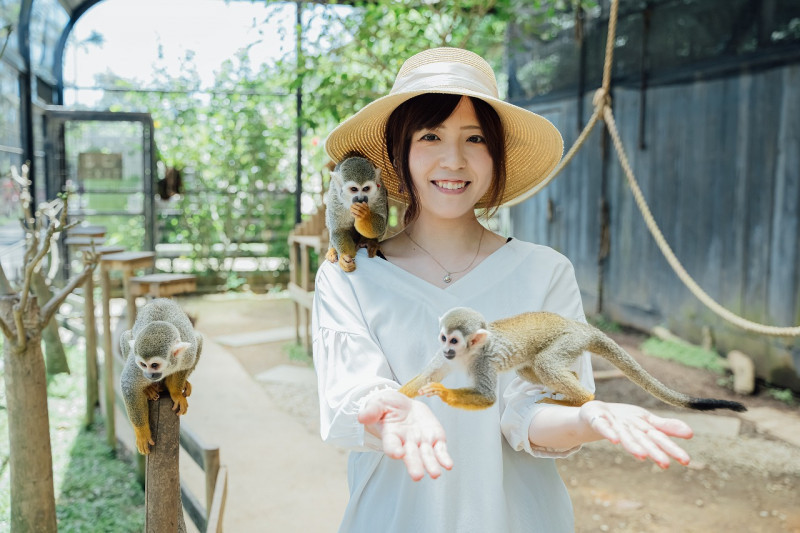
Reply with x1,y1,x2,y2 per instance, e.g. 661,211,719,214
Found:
389,61,498,98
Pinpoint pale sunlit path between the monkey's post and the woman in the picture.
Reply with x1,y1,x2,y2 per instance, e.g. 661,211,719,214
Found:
181,337,347,533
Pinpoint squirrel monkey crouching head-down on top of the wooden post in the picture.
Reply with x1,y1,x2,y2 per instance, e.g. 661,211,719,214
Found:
120,298,203,455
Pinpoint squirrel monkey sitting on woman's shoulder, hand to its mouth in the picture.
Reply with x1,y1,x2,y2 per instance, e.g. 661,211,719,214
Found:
325,153,388,272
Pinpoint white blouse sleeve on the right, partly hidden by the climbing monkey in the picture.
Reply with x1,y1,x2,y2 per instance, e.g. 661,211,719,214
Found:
500,254,595,457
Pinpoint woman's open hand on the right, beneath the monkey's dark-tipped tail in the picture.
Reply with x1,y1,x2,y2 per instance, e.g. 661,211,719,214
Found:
580,400,693,468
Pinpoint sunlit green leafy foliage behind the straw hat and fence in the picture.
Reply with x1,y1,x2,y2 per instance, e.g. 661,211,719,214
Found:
70,0,585,271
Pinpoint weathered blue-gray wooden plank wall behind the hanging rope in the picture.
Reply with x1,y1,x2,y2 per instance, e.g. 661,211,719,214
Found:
511,64,800,390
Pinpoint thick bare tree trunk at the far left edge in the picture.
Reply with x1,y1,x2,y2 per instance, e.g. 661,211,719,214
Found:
0,295,56,533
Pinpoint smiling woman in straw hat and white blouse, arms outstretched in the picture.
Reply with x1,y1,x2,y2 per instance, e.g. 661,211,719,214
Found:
313,48,691,533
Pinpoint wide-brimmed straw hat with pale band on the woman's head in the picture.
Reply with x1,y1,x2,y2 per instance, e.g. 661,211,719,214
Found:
325,48,564,207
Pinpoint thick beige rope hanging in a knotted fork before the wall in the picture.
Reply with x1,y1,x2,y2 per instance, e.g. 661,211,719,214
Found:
508,0,800,337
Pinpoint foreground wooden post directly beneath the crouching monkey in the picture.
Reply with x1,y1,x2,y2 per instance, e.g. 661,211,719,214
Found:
144,394,186,533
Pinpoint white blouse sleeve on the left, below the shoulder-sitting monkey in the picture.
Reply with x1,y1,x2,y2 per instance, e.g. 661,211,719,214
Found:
312,263,400,451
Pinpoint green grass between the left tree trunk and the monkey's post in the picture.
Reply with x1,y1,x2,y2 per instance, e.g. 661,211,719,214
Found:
0,336,144,533
